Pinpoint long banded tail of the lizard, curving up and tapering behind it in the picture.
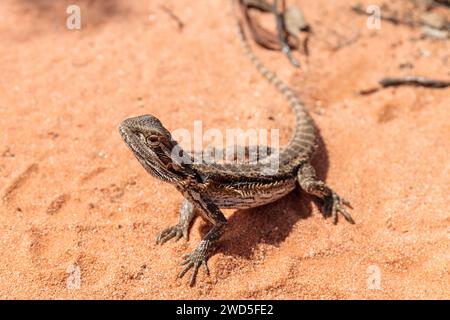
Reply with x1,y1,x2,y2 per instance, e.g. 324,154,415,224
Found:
236,21,317,163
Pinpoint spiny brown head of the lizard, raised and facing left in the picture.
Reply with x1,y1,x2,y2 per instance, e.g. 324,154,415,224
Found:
119,115,190,182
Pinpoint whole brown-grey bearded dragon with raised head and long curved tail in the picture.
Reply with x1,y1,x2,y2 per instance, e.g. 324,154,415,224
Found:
119,13,354,286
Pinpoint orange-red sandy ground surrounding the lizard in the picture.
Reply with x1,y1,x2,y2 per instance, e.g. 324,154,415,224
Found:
0,0,450,299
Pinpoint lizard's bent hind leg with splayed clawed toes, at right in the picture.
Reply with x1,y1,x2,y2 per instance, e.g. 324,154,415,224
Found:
297,164,355,224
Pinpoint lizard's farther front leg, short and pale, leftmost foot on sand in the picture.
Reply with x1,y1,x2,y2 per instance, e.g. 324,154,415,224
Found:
156,199,196,244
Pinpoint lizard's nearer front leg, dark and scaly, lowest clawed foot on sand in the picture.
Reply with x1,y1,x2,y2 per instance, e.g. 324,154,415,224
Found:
178,191,227,286
